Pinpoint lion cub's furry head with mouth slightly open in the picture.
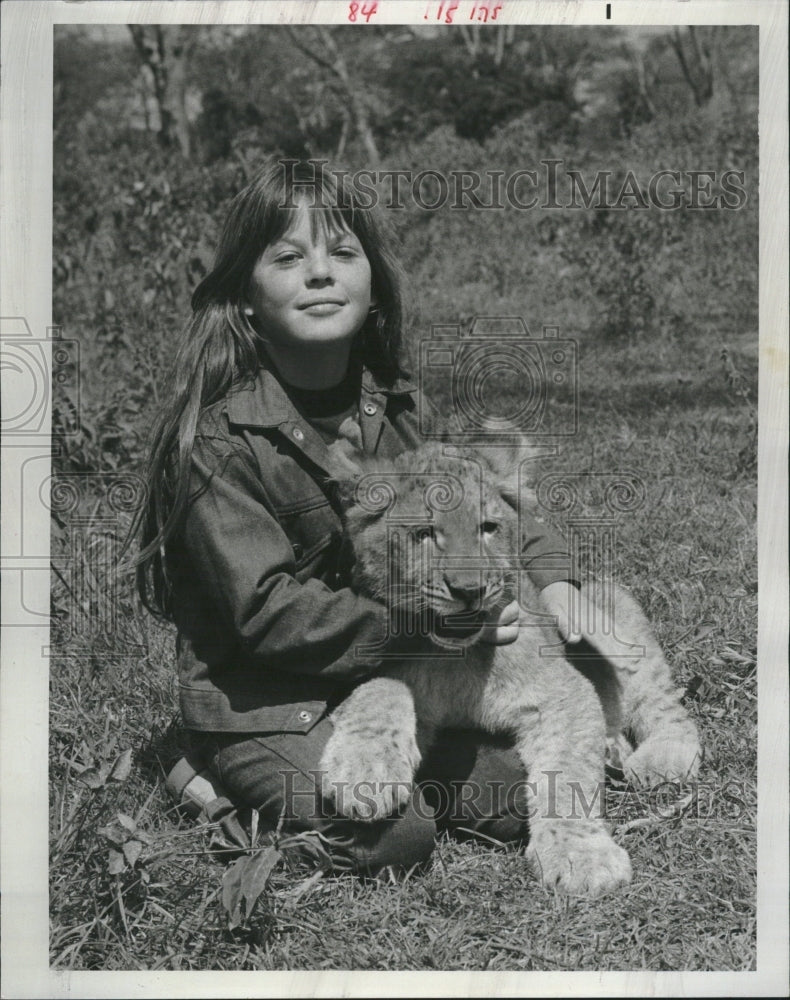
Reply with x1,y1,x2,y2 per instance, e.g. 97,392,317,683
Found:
346,446,518,641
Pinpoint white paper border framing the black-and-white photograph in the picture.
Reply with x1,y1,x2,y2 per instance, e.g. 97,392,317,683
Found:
0,0,790,998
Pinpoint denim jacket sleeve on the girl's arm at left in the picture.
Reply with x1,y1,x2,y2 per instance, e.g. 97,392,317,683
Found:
182,436,387,682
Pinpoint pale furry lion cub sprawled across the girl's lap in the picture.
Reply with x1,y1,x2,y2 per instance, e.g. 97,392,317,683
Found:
321,445,700,895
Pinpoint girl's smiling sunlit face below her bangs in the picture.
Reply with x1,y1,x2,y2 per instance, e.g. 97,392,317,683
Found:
247,204,371,352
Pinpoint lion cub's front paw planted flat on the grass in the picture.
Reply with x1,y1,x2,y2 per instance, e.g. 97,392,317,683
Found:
526,820,631,896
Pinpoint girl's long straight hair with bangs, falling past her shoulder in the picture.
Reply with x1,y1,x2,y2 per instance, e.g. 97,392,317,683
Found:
129,160,404,618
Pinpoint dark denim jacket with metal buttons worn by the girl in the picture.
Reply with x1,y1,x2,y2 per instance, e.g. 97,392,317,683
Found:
173,368,567,732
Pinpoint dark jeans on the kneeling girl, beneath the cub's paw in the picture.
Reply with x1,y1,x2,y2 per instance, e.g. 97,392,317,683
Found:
192,718,528,875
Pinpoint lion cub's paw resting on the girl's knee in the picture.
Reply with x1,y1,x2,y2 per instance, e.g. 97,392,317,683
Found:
320,730,420,823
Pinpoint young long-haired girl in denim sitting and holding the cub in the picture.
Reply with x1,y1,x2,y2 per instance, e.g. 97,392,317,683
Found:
138,161,580,873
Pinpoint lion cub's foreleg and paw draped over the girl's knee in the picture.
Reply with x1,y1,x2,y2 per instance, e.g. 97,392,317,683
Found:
320,677,420,822
